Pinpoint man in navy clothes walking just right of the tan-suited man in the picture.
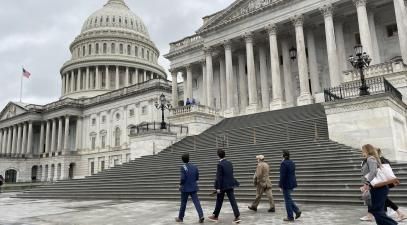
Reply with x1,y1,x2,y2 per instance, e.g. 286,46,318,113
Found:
279,150,301,222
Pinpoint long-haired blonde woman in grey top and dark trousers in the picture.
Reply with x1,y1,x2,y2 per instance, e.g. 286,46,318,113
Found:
360,144,397,225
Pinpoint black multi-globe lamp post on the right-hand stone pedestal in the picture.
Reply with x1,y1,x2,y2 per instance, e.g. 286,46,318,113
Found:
348,45,372,96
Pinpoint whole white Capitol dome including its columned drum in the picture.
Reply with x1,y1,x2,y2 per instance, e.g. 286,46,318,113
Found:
61,0,167,99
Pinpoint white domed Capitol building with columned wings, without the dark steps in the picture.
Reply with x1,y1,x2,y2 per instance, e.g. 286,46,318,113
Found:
0,0,407,182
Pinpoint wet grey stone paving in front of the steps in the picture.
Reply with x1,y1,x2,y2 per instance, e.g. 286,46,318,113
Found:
0,193,407,225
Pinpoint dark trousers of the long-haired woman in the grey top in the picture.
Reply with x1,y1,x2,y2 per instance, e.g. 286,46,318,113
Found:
369,186,397,225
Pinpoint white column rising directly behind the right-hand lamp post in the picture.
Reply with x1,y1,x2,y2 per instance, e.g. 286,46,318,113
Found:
353,0,378,64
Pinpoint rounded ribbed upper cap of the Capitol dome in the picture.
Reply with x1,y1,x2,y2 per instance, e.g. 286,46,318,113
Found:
82,0,150,38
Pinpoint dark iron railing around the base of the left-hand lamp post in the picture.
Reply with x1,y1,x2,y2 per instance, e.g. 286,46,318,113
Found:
128,122,189,136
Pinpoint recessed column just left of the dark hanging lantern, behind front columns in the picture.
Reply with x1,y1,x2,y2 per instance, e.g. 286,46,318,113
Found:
281,37,295,107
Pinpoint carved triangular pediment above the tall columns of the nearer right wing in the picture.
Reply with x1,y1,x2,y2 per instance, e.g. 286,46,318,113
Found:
197,0,290,33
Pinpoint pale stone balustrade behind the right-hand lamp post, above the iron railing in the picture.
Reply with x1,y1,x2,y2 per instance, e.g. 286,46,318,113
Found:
343,61,407,82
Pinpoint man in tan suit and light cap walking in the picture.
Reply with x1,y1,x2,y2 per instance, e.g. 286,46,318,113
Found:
248,155,275,212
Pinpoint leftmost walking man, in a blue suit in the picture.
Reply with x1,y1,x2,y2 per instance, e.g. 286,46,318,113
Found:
175,153,204,223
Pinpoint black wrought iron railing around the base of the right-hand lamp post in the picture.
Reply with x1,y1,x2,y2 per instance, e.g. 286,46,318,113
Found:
324,77,403,102
